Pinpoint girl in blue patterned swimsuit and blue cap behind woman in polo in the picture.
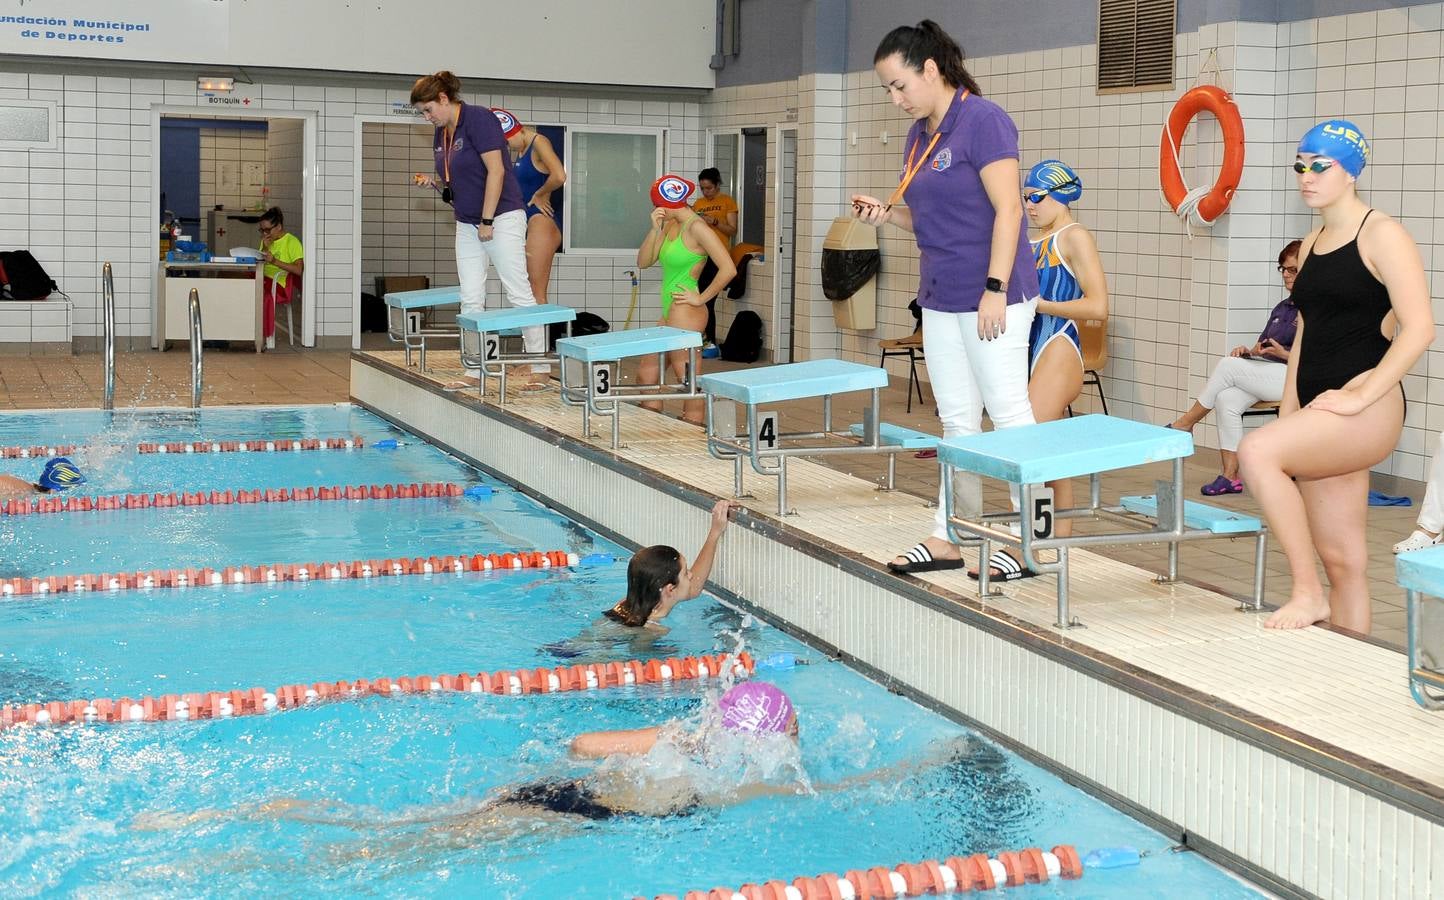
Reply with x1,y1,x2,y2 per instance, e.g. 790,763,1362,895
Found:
969,159,1108,581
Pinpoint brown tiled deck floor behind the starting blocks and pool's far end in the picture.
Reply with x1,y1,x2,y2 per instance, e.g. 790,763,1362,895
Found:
0,339,1422,646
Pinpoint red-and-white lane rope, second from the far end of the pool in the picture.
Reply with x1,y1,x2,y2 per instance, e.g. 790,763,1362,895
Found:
0,481,464,516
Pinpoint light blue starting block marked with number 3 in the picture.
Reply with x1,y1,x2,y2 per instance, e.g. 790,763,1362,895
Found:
556,325,702,449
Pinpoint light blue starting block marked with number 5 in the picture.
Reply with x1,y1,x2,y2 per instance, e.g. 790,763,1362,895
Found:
937,415,1268,628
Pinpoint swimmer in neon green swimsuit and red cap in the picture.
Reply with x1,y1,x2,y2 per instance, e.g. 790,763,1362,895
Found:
637,175,736,425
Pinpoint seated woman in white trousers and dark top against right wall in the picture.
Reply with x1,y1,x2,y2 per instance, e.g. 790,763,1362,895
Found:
1168,241,1302,497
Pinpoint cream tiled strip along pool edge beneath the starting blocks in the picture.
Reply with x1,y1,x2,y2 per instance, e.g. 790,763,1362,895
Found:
358,346,1444,792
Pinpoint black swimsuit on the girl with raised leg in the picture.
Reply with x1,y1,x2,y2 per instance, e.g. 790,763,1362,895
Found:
1294,209,1392,406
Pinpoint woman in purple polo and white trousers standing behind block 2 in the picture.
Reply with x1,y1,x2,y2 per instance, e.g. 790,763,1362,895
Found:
412,72,546,390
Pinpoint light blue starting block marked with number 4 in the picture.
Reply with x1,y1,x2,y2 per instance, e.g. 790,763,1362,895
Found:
699,360,937,516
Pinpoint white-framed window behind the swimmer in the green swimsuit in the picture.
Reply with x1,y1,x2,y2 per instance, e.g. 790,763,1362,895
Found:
566,126,661,253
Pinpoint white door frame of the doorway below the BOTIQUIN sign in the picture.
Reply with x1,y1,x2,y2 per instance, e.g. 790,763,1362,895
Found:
150,103,321,347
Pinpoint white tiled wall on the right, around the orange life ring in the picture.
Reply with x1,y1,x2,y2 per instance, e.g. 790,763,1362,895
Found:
703,4,1444,478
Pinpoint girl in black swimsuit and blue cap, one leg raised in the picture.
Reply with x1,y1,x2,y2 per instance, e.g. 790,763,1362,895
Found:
1239,118,1434,634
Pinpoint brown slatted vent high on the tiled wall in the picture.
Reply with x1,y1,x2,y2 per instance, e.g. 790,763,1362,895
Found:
1097,0,1178,91
